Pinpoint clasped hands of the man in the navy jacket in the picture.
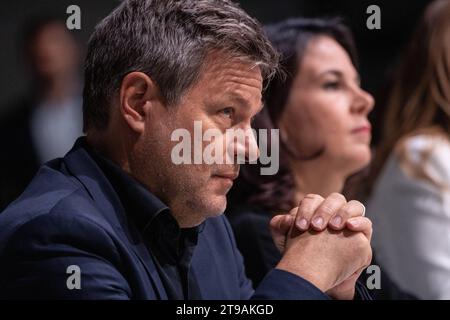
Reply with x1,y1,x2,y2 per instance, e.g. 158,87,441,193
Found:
270,193,372,299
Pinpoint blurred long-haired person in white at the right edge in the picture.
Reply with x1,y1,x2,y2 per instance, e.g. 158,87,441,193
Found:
367,0,450,299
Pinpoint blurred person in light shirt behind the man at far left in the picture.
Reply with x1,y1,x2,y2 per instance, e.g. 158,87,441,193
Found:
0,17,82,210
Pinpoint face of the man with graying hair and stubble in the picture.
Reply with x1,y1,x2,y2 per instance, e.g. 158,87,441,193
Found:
137,53,262,227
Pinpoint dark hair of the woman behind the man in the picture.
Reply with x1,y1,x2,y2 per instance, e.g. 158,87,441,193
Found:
228,18,357,213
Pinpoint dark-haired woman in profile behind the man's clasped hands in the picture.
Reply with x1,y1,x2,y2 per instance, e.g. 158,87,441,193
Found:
229,18,414,298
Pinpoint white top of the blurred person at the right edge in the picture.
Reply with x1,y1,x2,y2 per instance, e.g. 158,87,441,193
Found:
367,135,450,299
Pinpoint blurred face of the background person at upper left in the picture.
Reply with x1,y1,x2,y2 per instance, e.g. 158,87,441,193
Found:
28,22,79,80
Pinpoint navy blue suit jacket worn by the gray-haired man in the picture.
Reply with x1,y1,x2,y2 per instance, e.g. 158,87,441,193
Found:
0,138,327,299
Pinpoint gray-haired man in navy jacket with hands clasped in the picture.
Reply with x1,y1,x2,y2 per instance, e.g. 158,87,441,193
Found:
0,0,371,299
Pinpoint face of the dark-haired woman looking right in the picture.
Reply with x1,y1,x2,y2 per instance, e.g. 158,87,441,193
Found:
279,36,374,174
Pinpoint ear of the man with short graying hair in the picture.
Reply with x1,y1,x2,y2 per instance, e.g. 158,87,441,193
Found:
119,72,160,133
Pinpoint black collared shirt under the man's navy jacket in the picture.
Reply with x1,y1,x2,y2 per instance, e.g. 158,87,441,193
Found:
88,144,203,300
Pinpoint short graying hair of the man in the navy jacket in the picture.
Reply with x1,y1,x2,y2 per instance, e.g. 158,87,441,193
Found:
83,0,279,131
